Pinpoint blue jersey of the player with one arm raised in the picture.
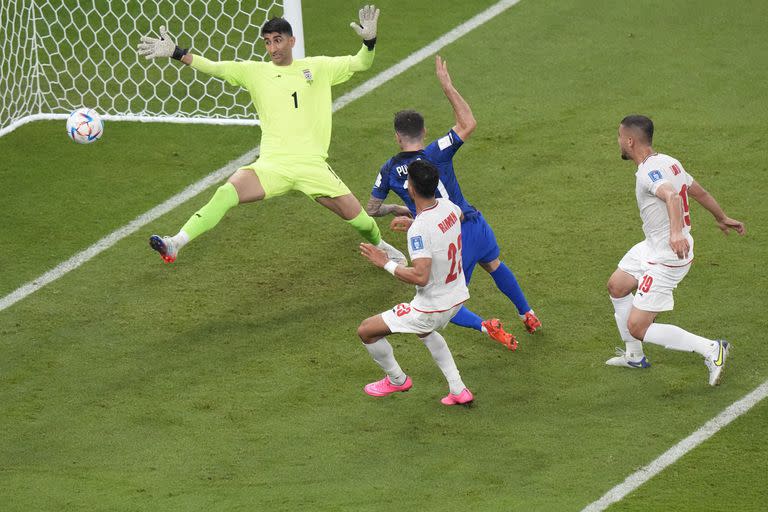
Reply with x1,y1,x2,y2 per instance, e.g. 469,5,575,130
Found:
371,130,477,217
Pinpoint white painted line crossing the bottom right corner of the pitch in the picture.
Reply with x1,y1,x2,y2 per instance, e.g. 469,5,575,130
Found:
582,380,768,512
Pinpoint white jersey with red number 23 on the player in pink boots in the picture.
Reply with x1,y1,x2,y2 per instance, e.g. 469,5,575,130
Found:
408,199,469,313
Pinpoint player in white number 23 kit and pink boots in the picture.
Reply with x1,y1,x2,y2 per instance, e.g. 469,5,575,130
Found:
357,160,474,405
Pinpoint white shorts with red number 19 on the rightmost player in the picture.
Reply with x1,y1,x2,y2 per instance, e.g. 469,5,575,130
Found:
619,241,691,312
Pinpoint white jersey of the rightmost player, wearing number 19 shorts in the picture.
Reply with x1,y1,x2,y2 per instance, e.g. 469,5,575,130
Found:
635,153,693,266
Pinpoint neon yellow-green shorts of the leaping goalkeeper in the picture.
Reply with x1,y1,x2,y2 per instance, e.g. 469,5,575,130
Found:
243,158,351,199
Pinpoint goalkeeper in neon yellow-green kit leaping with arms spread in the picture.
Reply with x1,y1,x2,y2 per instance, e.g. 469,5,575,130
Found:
138,5,405,263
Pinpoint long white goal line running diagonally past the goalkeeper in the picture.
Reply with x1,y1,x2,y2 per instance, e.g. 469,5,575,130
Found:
0,0,520,311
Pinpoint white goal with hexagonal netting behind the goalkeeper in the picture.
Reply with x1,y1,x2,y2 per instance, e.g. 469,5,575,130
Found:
0,0,304,137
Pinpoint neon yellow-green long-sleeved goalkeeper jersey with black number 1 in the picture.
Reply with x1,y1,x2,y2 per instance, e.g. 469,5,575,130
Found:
191,46,374,159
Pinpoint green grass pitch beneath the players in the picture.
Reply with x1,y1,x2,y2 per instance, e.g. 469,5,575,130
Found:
0,0,768,512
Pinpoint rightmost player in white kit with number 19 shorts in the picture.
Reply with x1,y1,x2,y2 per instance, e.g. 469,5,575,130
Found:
606,115,744,386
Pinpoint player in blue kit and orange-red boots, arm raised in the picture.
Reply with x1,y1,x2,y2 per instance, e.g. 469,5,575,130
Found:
366,55,541,349
